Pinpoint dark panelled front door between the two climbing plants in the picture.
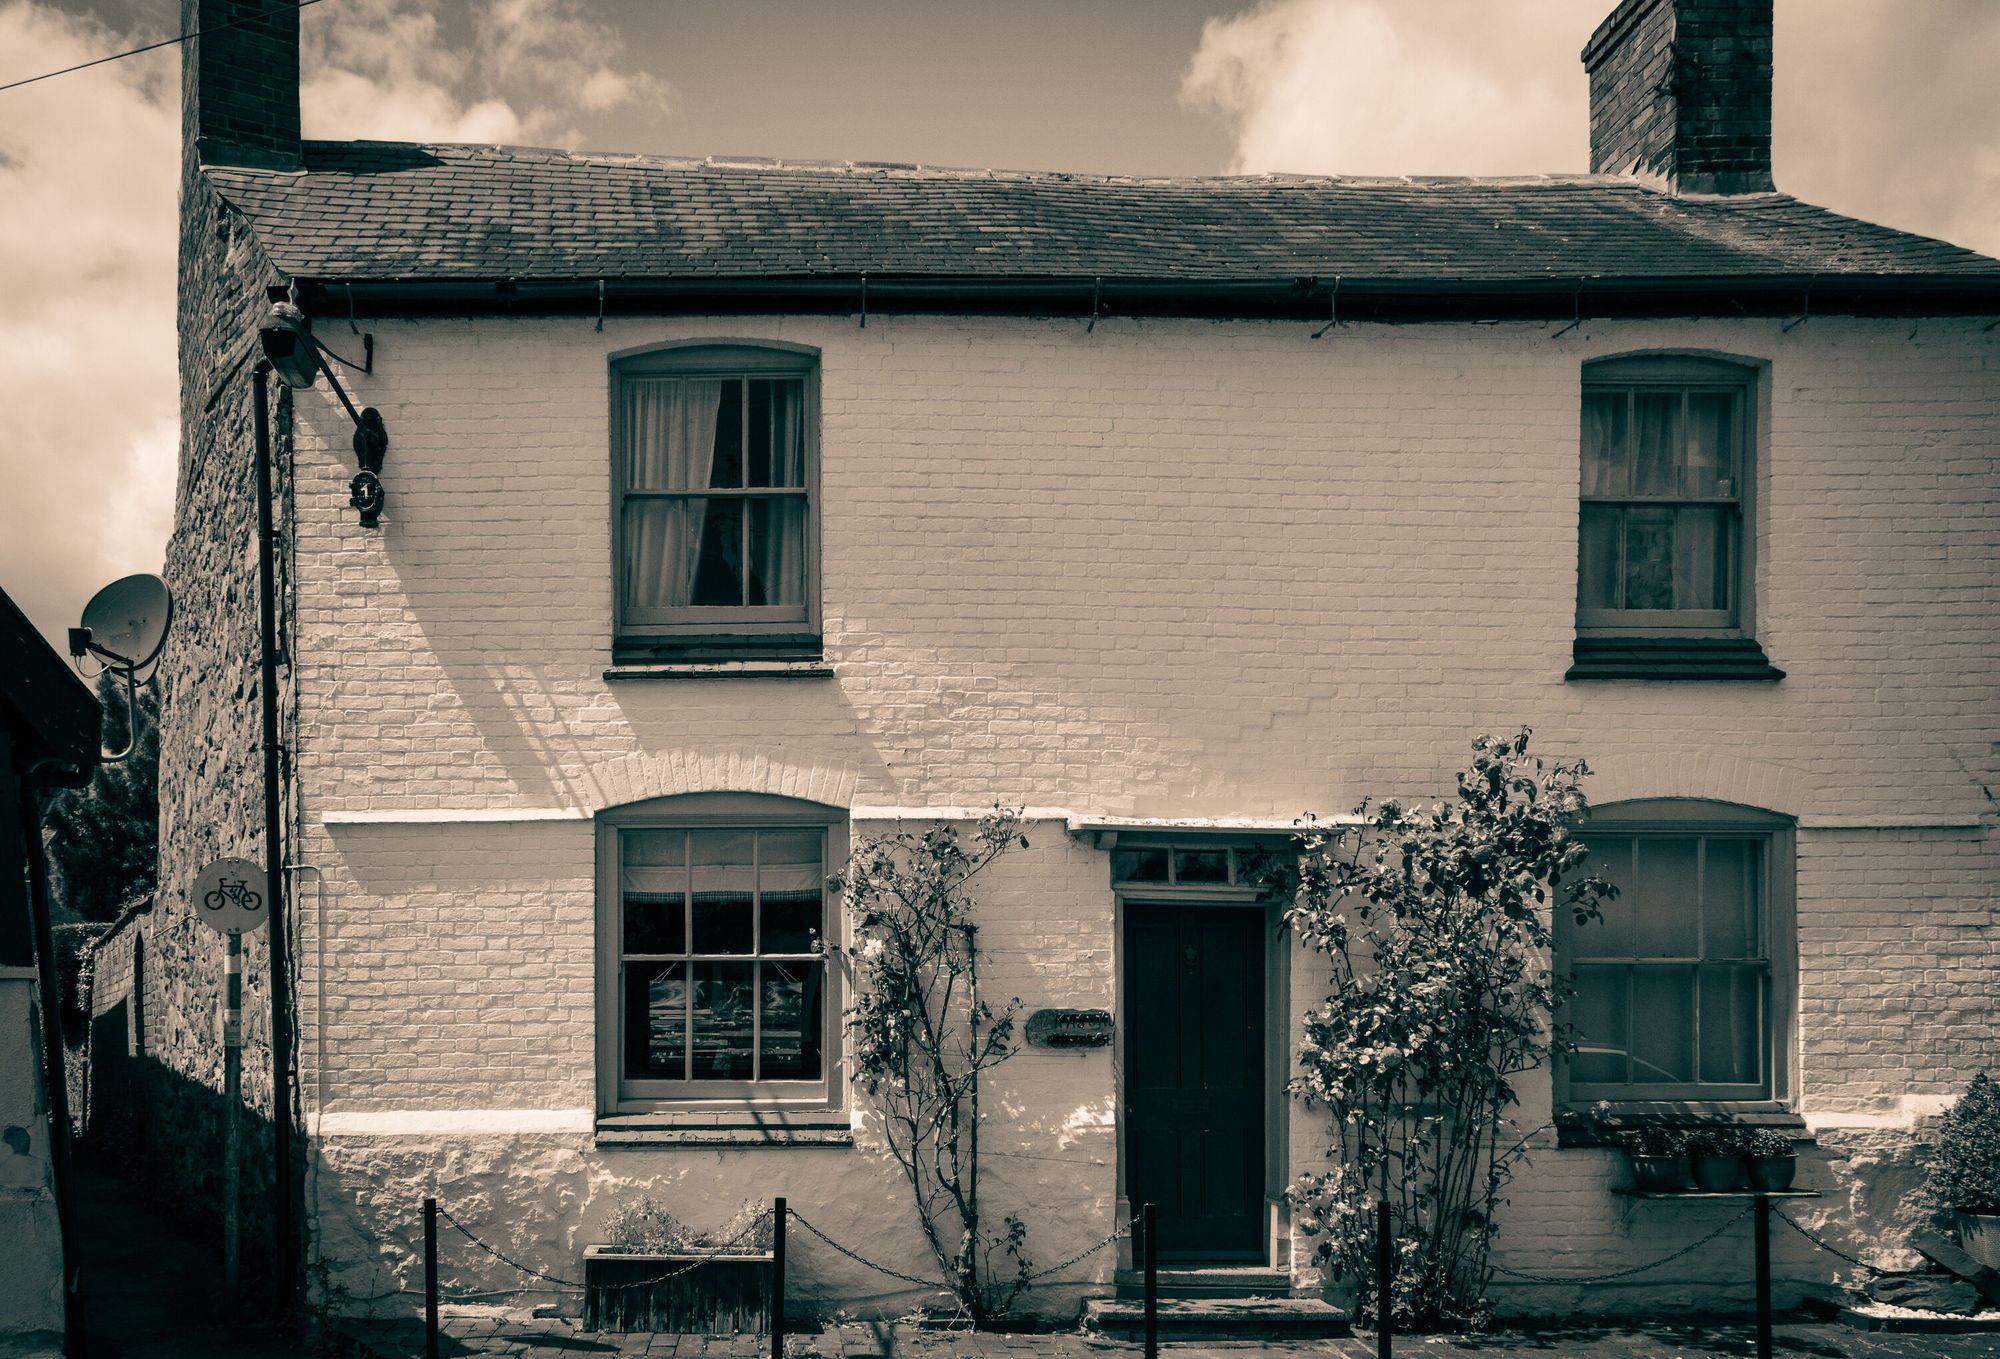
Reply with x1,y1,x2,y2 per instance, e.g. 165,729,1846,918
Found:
1124,903,1264,1261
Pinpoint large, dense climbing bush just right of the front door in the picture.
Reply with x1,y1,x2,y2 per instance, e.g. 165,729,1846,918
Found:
1286,727,1616,1329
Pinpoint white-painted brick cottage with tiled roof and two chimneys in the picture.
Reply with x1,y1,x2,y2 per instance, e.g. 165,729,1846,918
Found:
100,0,2000,1313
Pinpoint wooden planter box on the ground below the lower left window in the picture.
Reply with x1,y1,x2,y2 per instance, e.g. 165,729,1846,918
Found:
584,1245,772,1335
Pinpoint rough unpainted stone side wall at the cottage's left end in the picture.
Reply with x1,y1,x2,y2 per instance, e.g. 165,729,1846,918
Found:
140,161,292,1287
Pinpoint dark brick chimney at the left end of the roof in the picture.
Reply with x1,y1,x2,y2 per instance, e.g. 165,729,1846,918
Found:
180,0,300,170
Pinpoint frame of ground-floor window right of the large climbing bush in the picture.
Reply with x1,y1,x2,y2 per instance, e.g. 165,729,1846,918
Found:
1554,797,1798,1113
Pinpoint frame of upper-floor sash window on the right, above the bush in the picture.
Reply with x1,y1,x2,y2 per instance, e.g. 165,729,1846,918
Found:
1576,354,1758,638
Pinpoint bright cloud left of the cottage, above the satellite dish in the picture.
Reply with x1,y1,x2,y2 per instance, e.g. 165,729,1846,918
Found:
0,4,180,634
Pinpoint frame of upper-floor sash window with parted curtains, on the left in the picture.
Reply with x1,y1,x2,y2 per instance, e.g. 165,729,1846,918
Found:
610,340,820,646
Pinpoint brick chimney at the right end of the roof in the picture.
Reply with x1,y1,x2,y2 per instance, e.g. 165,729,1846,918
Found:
1584,0,1772,194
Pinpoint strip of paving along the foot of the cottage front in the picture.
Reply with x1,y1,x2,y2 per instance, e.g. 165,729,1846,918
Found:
332,1313,2000,1359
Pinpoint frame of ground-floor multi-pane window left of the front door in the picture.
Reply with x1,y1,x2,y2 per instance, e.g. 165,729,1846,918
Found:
596,793,848,1115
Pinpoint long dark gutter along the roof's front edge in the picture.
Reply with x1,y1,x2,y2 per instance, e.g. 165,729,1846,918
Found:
296,272,2000,322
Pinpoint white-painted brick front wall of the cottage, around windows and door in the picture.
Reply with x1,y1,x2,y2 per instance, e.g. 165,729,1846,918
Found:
296,316,2000,1311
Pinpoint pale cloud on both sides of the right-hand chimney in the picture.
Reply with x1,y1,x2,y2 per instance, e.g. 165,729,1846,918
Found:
1182,0,2000,254
